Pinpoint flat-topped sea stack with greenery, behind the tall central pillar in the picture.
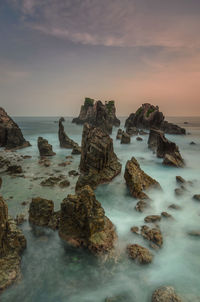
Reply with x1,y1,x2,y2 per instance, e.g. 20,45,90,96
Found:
72,98,120,134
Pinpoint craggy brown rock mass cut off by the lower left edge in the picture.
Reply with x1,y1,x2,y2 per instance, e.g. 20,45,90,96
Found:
0,197,26,292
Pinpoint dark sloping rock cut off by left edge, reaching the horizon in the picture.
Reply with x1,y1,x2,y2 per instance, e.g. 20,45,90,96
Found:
0,107,30,149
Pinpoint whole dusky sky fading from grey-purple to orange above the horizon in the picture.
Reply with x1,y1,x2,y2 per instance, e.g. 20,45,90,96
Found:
0,0,200,116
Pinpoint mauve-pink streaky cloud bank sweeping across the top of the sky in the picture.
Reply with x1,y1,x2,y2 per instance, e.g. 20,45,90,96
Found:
8,0,200,48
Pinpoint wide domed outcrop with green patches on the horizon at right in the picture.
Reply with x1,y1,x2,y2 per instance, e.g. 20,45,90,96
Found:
125,103,186,134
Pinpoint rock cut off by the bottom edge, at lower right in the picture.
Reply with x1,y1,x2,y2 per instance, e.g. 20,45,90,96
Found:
151,286,182,302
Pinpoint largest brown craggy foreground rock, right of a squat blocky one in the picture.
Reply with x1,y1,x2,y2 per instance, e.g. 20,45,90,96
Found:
59,186,117,254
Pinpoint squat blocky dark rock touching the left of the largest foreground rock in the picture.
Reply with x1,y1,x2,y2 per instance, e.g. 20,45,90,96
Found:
29,197,60,229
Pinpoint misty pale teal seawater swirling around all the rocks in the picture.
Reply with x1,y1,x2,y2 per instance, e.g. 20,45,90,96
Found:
0,117,200,302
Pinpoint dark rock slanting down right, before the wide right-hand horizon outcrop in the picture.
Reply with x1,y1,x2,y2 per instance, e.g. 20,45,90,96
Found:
148,128,184,167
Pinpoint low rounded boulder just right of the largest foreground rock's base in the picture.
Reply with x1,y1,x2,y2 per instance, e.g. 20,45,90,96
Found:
127,244,153,264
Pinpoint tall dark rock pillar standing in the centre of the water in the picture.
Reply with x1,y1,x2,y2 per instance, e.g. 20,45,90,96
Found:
76,124,121,190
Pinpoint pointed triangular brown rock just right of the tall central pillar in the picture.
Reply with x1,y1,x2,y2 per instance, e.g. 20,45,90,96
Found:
124,157,160,199
